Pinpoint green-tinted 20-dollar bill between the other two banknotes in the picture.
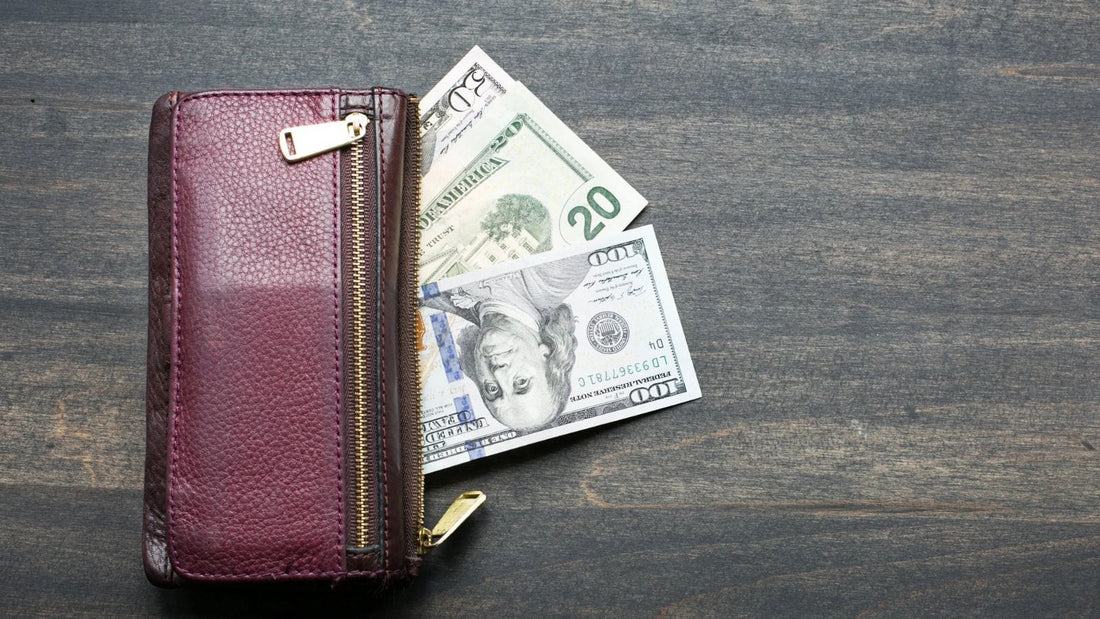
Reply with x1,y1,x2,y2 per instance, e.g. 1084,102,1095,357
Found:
419,81,647,284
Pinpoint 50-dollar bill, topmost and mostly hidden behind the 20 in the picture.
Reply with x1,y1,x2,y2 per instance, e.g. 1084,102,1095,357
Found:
420,45,515,175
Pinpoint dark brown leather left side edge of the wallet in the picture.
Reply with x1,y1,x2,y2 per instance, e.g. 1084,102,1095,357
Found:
142,92,179,587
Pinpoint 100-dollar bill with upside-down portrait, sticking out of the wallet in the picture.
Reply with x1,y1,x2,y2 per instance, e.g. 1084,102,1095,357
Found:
418,226,701,473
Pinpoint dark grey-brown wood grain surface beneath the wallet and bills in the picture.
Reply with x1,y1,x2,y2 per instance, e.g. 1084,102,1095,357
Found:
0,0,1100,616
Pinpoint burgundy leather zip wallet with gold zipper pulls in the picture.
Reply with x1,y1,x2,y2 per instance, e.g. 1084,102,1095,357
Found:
142,88,484,586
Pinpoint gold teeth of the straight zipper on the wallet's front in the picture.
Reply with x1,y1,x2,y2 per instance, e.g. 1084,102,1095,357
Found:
350,136,370,548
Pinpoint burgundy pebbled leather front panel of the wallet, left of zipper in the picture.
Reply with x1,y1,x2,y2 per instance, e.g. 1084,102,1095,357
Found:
167,90,344,581
